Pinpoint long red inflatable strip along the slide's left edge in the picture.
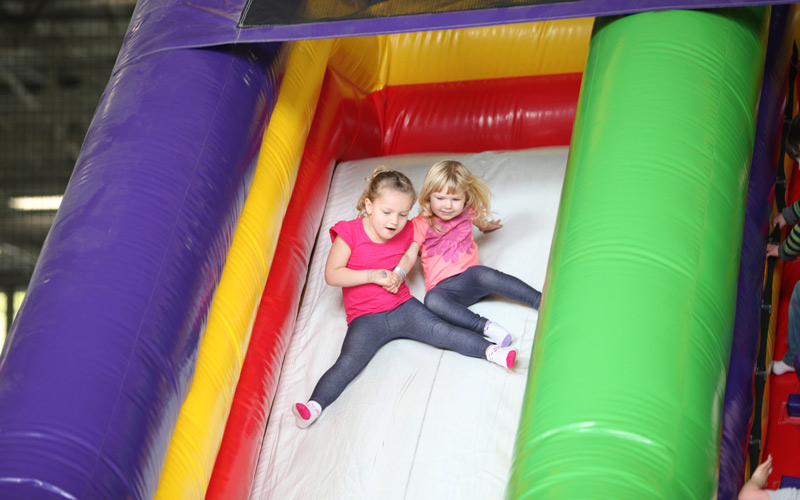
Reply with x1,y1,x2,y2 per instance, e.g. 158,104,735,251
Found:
206,72,353,500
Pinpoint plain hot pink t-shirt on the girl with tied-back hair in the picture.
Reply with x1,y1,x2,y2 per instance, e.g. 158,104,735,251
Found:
330,219,414,325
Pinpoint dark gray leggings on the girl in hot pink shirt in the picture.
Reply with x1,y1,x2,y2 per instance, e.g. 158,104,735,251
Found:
311,298,491,409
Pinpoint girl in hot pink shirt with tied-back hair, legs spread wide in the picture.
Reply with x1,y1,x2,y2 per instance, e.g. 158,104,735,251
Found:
292,167,517,428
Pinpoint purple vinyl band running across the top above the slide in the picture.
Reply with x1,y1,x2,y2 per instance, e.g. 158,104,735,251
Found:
115,0,794,63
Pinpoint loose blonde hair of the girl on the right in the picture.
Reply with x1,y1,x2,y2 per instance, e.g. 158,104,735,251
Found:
419,160,492,231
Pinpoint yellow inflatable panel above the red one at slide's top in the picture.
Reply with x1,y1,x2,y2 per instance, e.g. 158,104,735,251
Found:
330,18,594,93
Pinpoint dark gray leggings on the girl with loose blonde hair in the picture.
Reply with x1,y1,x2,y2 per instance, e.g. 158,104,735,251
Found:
425,265,542,333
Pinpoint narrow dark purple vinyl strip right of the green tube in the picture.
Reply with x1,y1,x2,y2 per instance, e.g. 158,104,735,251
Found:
718,6,792,499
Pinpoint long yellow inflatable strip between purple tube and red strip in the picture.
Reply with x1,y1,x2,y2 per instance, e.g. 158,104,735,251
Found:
156,40,333,500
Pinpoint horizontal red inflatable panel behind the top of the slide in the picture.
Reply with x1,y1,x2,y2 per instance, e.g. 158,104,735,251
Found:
362,73,582,155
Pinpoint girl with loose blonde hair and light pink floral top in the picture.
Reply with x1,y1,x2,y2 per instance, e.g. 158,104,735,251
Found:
396,160,542,347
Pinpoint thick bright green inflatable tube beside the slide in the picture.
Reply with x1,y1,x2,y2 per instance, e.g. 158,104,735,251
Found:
506,7,769,500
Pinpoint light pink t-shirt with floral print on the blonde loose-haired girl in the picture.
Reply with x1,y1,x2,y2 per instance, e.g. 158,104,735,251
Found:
411,209,478,292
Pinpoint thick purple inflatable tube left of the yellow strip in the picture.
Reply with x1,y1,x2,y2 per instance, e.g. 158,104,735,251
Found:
0,44,279,499
